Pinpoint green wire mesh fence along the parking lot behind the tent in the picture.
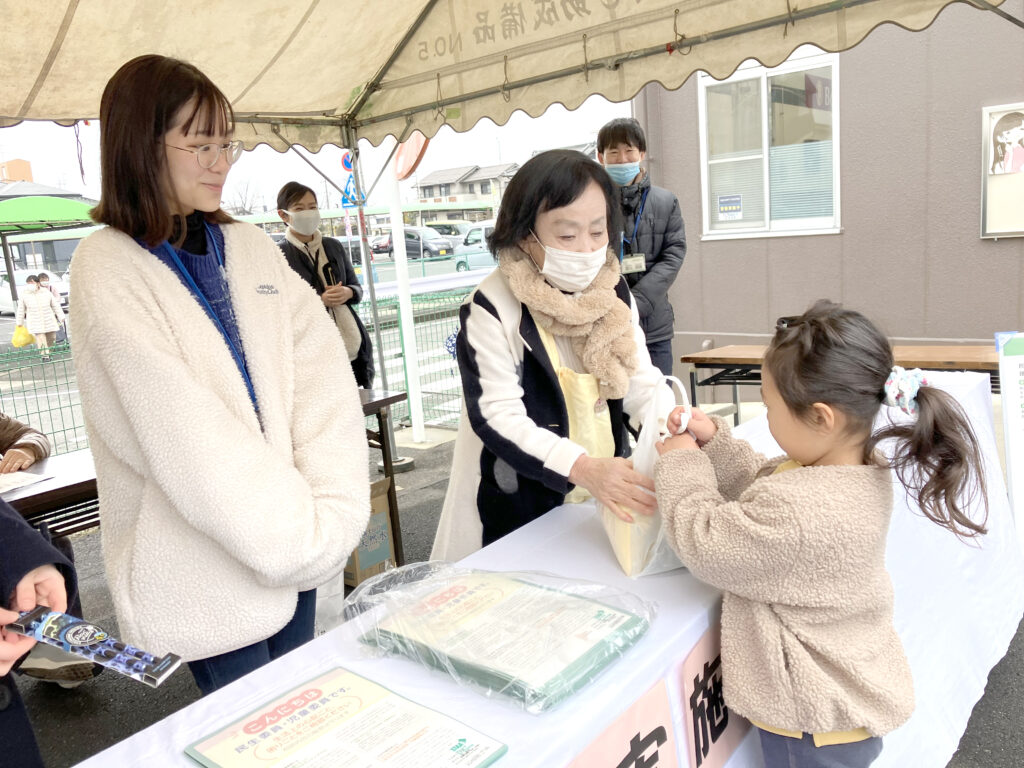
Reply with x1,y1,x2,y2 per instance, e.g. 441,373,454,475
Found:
0,288,472,454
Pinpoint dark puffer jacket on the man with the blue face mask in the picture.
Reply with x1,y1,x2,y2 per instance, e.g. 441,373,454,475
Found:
618,172,686,343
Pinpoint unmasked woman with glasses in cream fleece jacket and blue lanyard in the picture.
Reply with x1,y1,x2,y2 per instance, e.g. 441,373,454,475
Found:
73,55,370,693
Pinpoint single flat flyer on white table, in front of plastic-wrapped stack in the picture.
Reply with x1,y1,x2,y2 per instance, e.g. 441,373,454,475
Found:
185,668,508,768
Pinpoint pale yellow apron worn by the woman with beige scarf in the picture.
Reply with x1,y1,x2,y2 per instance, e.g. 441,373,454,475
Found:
537,326,615,504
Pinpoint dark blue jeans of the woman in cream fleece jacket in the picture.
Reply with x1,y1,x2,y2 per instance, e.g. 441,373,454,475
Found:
188,590,316,696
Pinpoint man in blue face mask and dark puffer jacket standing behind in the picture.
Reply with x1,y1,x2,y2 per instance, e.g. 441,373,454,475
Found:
597,118,686,376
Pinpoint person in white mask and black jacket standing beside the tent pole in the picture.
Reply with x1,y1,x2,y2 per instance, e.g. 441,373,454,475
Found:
278,181,374,389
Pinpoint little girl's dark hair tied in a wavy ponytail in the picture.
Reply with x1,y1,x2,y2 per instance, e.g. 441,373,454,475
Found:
764,299,988,538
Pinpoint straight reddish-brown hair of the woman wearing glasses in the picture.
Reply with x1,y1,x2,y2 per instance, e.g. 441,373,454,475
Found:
90,54,234,247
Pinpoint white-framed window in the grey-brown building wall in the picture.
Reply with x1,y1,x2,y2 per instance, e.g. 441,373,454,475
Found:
698,51,840,237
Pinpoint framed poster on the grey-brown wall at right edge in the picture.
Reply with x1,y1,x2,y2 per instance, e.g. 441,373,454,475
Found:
981,101,1024,239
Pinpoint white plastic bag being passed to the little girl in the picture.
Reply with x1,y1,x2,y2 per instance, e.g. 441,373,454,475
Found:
598,376,690,579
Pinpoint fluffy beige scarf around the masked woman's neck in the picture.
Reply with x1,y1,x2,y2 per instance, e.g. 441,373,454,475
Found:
498,248,637,399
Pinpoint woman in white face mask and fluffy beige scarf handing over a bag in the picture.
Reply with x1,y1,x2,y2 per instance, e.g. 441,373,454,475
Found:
432,150,679,560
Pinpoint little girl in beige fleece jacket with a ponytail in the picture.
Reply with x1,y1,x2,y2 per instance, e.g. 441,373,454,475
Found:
654,301,985,768
